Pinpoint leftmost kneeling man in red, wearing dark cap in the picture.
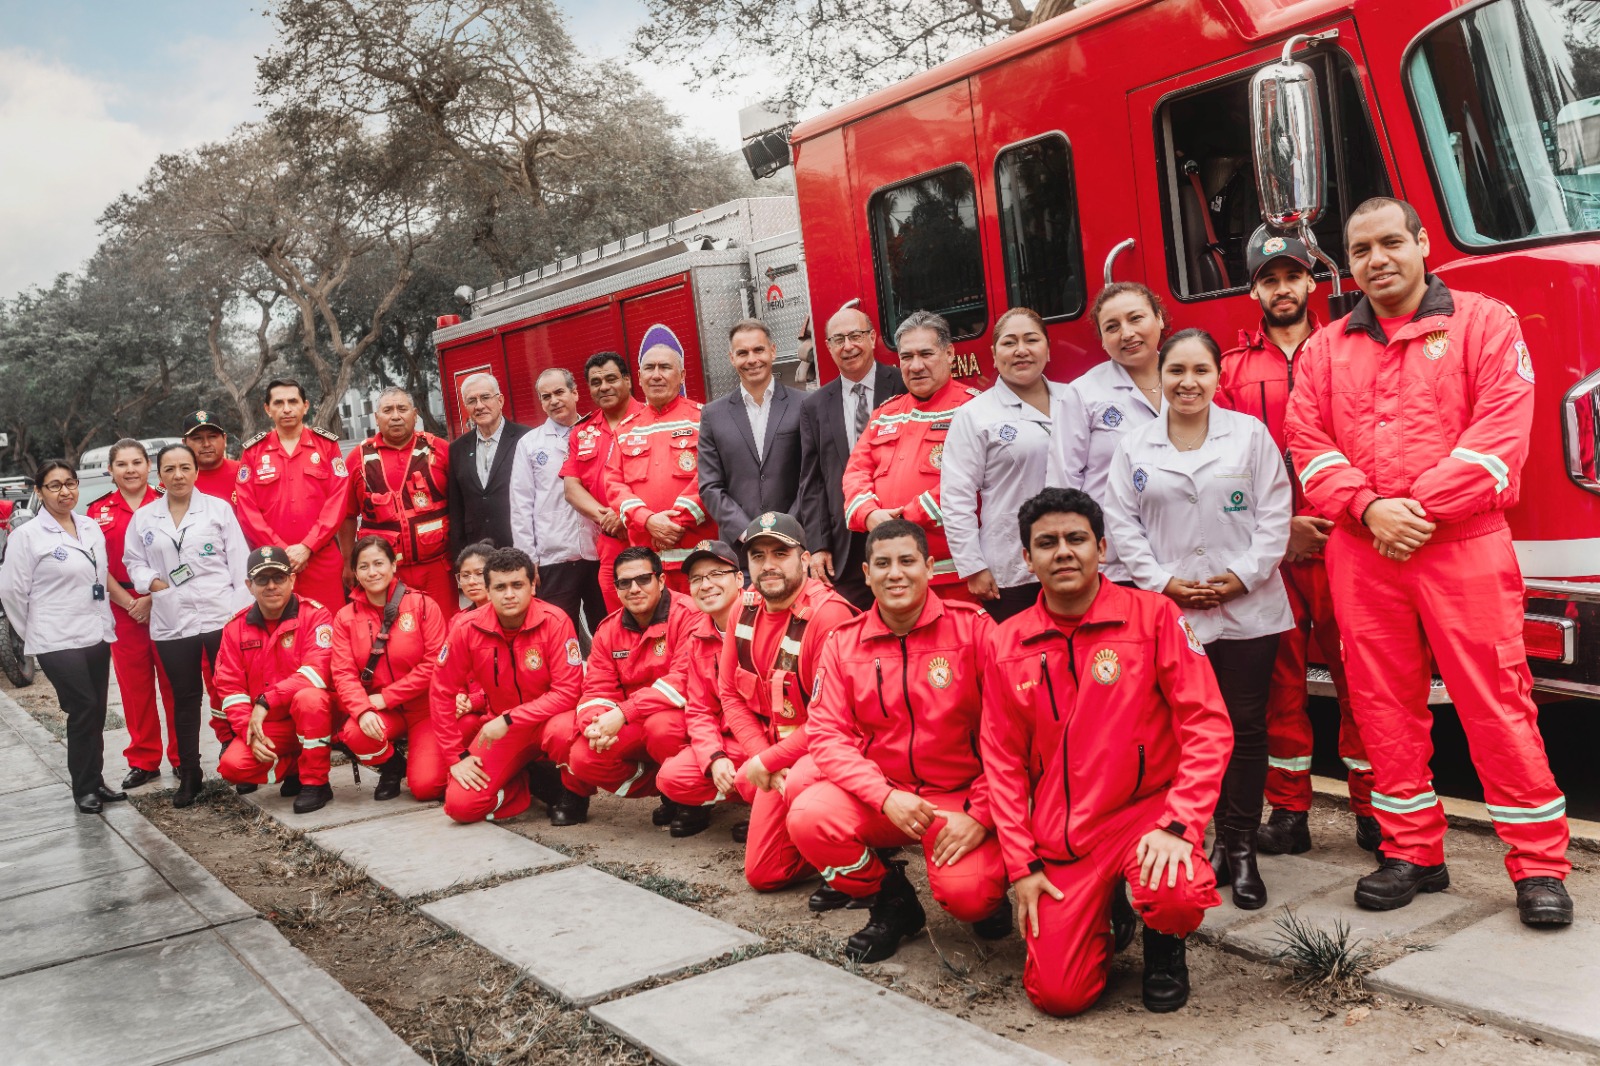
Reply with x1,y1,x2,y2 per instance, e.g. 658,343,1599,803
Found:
213,546,333,815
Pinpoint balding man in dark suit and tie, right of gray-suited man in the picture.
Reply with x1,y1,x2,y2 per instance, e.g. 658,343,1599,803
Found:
795,301,906,610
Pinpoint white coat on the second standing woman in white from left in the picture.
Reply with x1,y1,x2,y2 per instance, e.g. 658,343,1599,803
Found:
122,493,251,640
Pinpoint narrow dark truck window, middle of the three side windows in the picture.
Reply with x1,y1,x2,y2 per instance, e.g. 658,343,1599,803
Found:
995,133,1085,320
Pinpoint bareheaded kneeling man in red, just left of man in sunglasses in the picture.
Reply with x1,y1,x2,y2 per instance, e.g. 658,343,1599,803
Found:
429,547,584,821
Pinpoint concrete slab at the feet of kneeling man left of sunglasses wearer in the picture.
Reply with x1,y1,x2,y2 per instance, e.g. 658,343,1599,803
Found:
310,808,570,896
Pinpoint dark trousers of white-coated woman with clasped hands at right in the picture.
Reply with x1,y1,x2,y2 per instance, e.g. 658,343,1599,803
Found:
1205,634,1278,831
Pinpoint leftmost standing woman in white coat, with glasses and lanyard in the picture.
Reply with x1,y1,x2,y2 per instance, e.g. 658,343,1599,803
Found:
0,459,128,815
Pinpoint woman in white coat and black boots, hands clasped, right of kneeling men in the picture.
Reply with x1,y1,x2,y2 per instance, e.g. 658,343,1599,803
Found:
1106,330,1294,909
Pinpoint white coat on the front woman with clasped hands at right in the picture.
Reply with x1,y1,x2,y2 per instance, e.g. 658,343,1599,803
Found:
1106,405,1294,643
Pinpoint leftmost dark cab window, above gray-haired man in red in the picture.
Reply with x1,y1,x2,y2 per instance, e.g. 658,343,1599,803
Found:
867,166,989,339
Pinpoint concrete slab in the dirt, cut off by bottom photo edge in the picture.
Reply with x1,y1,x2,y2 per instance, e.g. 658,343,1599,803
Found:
589,952,1090,1066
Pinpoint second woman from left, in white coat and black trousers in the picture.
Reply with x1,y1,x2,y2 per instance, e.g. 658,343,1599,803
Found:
123,443,251,807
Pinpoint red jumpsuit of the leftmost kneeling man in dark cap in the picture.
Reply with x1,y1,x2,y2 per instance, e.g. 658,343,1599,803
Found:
213,595,333,784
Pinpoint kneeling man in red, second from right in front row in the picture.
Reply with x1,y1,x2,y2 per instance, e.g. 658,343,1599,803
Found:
789,519,1011,962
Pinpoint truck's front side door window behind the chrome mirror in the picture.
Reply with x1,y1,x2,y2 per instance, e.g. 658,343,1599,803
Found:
1155,50,1389,299
